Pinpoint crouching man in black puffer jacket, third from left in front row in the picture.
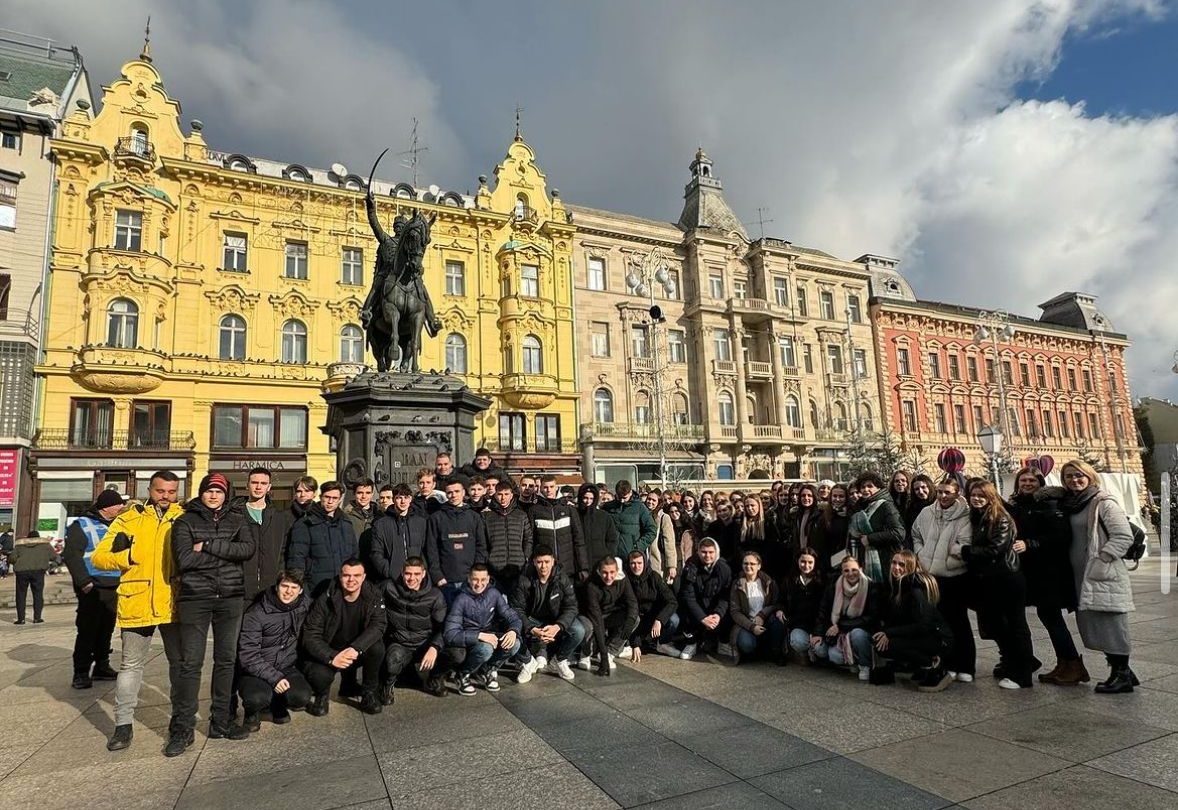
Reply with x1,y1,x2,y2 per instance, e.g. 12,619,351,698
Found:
380,557,451,706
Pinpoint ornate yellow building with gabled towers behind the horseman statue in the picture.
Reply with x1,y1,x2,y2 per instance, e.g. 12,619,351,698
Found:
32,47,578,519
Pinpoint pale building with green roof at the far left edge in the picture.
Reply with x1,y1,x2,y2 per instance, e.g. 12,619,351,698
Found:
0,31,92,526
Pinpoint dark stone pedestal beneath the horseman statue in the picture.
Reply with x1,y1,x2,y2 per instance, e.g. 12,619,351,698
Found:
323,371,491,491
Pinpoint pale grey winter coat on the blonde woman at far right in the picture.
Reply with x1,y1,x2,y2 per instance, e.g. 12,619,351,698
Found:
1072,492,1134,613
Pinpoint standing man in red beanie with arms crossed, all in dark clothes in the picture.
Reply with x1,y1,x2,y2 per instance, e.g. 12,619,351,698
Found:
164,472,256,757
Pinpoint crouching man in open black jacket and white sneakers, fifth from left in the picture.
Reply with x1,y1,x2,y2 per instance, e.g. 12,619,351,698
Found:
511,545,585,683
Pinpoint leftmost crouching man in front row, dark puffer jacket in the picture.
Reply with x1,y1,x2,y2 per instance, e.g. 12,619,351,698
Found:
237,570,311,731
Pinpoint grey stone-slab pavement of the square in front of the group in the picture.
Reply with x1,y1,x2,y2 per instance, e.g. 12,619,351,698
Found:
0,560,1178,810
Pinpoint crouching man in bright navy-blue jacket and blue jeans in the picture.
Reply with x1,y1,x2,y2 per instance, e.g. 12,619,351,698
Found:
443,563,522,695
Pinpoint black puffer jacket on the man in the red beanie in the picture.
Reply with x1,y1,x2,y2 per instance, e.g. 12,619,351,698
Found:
172,498,257,602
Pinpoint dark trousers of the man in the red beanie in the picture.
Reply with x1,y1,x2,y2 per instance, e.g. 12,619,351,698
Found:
172,597,243,731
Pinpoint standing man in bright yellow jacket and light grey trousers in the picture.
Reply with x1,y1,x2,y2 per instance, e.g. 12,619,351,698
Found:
91,470,184,751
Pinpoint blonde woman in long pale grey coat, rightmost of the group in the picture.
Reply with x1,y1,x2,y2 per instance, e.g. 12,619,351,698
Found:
1060,460,1138,695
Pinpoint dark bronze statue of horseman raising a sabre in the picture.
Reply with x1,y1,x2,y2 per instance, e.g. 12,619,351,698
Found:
360,150,442,373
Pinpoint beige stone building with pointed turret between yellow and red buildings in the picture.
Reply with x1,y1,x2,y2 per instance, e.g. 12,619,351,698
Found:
569,150,879,482
